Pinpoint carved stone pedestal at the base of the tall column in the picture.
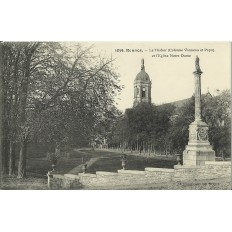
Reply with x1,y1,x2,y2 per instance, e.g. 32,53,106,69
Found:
183,119,215,166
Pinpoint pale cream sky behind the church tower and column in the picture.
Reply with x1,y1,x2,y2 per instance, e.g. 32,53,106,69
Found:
81,42,231,111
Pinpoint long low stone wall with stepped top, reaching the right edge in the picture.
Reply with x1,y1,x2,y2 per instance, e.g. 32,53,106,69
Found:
50,161,231,189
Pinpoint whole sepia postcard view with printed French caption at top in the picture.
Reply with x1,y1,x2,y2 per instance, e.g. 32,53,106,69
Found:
0,41,231,190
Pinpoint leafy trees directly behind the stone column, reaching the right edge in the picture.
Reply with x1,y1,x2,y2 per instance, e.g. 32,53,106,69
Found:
169,90,231,156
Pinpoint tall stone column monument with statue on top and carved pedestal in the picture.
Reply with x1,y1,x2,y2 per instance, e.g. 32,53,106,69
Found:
183,56,215,166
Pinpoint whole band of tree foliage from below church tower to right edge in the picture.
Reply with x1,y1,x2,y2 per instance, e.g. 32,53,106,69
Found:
111,90,231,156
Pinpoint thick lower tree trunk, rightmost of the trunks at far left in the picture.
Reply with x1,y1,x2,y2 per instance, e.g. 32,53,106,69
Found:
17,140,27,178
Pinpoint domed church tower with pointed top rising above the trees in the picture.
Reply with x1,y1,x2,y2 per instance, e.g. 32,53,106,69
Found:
134,59,151,106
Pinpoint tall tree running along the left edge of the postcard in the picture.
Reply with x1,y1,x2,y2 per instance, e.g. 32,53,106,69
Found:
2,43,24,174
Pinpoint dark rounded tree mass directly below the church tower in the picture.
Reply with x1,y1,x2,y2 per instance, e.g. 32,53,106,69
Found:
109,103,175,153
